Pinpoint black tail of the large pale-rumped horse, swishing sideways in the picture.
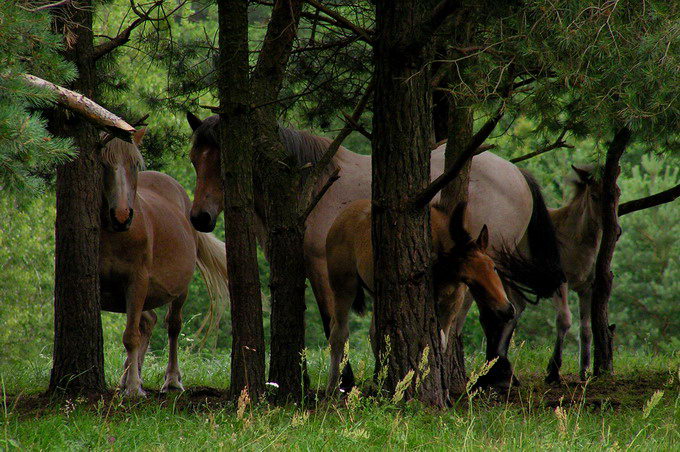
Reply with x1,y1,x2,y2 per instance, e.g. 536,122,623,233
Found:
498,170,567,301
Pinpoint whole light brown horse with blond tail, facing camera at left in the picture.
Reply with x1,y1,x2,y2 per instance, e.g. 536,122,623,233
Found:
99,130,228,396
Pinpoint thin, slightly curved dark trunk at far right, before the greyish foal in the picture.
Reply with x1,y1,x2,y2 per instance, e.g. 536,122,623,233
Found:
591,127,631,376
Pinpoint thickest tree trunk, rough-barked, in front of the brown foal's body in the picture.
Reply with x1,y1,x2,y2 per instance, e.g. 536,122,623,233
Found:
372,0,446,406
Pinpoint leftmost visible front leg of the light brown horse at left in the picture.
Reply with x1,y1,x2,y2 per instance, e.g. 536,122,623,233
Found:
121,271,149,397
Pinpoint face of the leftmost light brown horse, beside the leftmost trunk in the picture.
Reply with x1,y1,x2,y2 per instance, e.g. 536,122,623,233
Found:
101,129,146,232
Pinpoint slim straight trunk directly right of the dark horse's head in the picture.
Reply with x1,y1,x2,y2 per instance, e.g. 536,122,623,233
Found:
217,0,265,399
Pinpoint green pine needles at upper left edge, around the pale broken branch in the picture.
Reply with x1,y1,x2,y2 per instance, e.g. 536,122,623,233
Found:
0,1,75,198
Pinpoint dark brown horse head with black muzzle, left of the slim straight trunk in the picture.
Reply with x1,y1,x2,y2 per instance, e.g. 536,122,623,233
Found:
187,113,224,232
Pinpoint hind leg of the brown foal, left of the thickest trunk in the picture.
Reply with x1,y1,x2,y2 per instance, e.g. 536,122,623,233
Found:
326,286,358,395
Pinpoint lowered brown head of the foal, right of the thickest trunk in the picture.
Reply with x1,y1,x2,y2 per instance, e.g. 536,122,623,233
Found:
435,202,515,319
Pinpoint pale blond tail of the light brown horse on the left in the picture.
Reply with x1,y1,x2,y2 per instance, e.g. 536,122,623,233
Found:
196,232,229,345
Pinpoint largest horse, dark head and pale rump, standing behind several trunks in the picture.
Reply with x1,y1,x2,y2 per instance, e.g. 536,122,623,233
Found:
187,113,564,388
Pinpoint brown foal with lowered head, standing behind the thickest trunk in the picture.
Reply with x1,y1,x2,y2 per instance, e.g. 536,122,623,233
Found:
326,199,515,394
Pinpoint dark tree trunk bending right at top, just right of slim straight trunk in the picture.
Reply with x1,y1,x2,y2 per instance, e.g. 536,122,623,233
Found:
251,0,308,403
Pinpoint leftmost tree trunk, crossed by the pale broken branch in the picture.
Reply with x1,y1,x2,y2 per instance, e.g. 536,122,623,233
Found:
49,1,106,393
